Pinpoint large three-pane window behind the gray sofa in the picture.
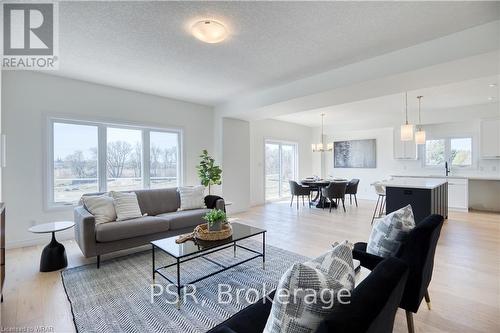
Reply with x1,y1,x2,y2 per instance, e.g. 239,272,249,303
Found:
47,119,181,207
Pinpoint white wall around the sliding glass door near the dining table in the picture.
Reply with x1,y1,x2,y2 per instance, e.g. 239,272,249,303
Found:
250,119,319,206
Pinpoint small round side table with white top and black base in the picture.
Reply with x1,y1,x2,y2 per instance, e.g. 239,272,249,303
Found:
29,221,75,272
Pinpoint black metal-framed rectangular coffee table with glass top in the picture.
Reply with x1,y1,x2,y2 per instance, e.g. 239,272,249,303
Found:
151,222,266,307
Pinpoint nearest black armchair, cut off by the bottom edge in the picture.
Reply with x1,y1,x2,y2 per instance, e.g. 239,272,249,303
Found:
209,258,408,333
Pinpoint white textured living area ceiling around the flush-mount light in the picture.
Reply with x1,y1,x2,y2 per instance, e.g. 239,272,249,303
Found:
52,1,500,105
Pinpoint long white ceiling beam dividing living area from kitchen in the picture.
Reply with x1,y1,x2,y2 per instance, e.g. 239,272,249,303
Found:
216,21,500,120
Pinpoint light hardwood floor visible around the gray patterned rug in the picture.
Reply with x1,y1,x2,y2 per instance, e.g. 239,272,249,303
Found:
1,200,500,332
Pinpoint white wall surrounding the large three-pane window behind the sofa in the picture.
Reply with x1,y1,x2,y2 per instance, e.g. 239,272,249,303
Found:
1,71,214,247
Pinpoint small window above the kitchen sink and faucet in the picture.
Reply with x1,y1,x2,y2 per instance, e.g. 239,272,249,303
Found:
425,138,472,167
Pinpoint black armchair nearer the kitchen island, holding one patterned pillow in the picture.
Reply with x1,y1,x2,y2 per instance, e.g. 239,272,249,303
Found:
353,215,444,332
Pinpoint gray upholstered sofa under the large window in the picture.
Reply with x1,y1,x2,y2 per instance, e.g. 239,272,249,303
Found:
74,188,225,268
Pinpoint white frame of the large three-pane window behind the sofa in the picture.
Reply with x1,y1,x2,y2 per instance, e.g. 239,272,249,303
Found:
42,116,184,211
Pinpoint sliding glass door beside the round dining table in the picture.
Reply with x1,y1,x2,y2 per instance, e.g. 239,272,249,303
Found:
264,141,297,201
